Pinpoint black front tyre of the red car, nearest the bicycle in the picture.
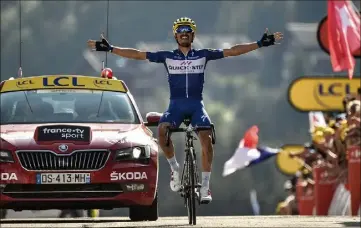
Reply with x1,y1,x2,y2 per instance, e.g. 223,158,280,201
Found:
129,193,158,221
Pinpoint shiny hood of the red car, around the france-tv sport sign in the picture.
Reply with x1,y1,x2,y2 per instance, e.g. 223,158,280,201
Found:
1,123,149,149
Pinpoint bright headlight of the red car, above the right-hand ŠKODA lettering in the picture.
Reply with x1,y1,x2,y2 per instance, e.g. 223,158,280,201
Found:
115,146,150,161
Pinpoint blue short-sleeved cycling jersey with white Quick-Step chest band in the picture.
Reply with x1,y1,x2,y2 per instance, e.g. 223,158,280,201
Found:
147,49,224,100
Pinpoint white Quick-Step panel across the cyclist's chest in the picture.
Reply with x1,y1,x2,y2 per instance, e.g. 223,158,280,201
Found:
166,57,206,74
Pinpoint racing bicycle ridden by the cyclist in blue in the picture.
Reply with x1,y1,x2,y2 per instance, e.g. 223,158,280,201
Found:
166,117,216,225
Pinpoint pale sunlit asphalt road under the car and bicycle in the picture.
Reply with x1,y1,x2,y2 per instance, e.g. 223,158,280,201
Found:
0,216,360,228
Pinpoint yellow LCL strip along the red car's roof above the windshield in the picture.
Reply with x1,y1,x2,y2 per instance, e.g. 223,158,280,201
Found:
1,75,127,92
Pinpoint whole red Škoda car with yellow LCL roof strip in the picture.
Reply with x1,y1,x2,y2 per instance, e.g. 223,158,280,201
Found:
0,75,159,220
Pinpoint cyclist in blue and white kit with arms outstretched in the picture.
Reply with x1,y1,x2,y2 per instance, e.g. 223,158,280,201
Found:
88,17,283,203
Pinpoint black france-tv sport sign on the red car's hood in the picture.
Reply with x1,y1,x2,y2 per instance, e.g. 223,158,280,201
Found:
35,125,91,142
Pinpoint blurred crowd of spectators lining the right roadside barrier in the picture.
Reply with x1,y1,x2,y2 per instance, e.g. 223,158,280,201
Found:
276,88,361,215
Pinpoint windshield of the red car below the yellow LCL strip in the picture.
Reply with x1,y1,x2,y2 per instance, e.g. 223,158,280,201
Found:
1,89,139,124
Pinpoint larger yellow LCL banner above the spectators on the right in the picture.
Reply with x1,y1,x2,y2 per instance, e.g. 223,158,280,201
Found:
288,76,361,112
